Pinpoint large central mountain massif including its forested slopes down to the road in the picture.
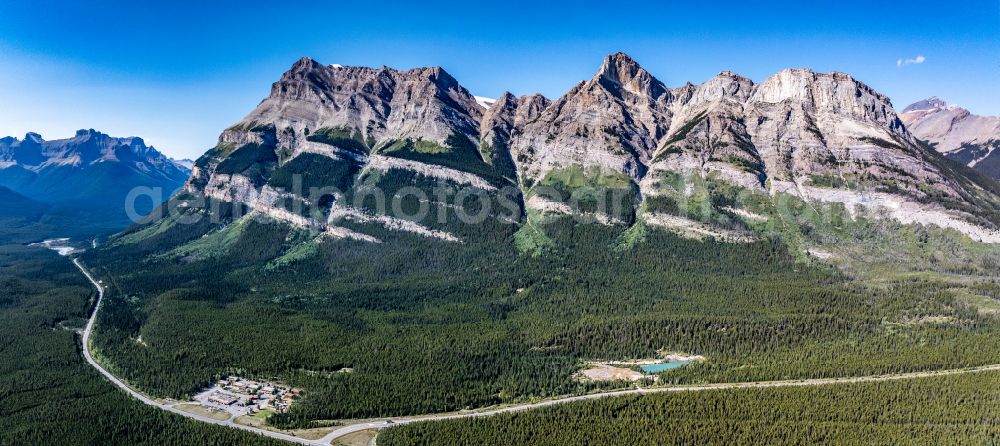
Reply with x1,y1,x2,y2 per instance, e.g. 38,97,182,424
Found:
81,53,1000,442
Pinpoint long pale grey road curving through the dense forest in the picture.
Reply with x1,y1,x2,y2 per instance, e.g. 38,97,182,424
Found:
73,259,1000,445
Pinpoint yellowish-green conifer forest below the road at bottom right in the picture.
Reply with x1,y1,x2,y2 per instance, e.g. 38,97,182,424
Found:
378,372,1000,446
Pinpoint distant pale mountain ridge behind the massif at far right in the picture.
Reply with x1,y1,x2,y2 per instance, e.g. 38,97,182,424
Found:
900,97,1000,179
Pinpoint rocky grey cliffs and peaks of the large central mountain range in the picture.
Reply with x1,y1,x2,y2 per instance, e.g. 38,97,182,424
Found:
152,53,1000,254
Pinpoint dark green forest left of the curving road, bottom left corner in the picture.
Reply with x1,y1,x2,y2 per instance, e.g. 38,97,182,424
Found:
0,246,284,446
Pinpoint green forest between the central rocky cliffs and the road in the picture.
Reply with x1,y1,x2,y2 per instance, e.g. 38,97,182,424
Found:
85,200,1000,427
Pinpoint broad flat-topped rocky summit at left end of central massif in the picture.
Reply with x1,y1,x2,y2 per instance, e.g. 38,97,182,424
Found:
238,58,483,148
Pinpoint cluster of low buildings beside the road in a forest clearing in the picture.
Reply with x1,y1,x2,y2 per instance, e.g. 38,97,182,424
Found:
206,376,301,413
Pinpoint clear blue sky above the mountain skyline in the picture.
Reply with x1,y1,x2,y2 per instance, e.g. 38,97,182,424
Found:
0,0,1000,158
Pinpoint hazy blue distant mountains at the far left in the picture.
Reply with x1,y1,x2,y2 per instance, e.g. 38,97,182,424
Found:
0,129,190,235
